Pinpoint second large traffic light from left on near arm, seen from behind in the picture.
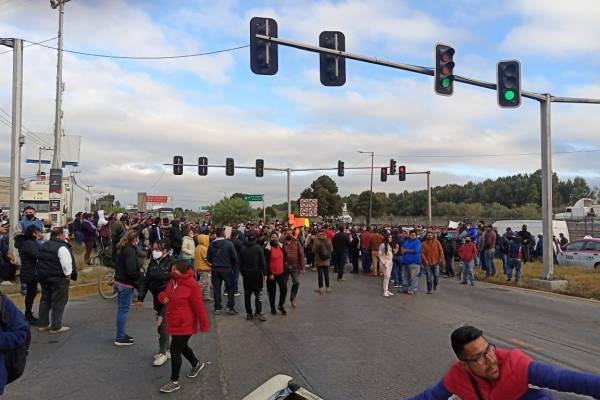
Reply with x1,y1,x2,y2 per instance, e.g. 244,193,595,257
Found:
319,31,346,86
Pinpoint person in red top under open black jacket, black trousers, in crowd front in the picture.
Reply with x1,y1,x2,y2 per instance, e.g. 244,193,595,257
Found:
265,230,288,315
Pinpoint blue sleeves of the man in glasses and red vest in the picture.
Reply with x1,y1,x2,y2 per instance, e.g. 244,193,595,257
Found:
409,361,600,400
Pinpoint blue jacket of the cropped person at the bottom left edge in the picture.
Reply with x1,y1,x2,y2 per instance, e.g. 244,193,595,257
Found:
0,296,29,395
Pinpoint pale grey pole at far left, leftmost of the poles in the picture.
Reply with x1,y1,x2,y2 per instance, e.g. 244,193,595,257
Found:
8,39,23,256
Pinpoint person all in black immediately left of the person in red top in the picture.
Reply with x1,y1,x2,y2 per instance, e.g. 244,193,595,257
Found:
240,234,267,321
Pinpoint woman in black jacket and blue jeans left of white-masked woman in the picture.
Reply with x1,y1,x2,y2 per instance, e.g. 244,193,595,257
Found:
115,230,142,346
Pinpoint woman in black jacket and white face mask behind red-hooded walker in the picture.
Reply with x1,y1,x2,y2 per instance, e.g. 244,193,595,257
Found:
137,240,174,367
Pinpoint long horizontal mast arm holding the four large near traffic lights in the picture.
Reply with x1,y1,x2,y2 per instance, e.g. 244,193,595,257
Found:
256,34,600,104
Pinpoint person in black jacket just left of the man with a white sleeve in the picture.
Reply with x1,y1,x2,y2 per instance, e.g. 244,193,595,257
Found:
15,225,44,325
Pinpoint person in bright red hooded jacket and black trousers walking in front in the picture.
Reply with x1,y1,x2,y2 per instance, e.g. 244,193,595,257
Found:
158,260,209,393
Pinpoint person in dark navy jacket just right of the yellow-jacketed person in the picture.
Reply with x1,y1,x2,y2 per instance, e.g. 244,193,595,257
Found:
207,228,238,315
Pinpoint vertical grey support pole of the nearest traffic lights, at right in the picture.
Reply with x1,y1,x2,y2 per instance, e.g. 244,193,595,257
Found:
540,94,554,280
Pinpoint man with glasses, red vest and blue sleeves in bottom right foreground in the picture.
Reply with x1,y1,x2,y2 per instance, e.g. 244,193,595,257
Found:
411,326,600,400
